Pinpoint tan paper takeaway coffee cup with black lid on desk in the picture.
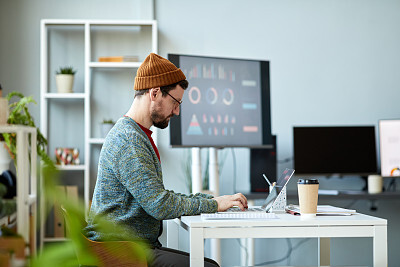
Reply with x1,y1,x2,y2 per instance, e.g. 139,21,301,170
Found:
297,179,319,217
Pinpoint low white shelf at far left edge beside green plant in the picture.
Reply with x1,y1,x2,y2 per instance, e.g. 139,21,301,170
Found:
0,125,37,253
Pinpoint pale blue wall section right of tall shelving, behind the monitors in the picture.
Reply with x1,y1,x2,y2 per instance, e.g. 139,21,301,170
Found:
156,0,400,266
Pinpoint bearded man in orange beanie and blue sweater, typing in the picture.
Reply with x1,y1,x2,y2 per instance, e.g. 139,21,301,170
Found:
86,53,247,266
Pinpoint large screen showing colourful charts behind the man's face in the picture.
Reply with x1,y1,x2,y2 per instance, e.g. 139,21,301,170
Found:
168,54,272,147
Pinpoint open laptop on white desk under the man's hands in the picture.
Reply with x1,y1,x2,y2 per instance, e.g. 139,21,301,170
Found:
217,168,294,214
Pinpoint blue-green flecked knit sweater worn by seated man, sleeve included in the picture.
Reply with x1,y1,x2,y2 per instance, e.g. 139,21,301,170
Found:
85,117,218,247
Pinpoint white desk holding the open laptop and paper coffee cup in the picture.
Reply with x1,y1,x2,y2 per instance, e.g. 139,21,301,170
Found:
168,214,388,267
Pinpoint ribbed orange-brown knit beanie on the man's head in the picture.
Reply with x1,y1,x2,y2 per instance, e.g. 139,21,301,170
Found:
134,53,186,90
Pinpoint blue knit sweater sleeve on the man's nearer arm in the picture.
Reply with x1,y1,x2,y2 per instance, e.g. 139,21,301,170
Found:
113,135,218,220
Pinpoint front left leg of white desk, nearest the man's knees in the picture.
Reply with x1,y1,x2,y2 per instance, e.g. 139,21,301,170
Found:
190,228,204,267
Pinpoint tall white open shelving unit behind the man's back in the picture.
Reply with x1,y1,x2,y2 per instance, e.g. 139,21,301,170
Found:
40,19,158,245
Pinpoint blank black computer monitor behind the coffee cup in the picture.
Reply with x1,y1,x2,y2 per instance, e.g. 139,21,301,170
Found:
293,126,377,176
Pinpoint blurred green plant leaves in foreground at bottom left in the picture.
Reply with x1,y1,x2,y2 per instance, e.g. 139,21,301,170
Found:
31,159,149,267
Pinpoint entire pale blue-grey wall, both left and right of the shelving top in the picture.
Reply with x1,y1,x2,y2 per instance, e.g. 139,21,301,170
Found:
0,0,400,266
